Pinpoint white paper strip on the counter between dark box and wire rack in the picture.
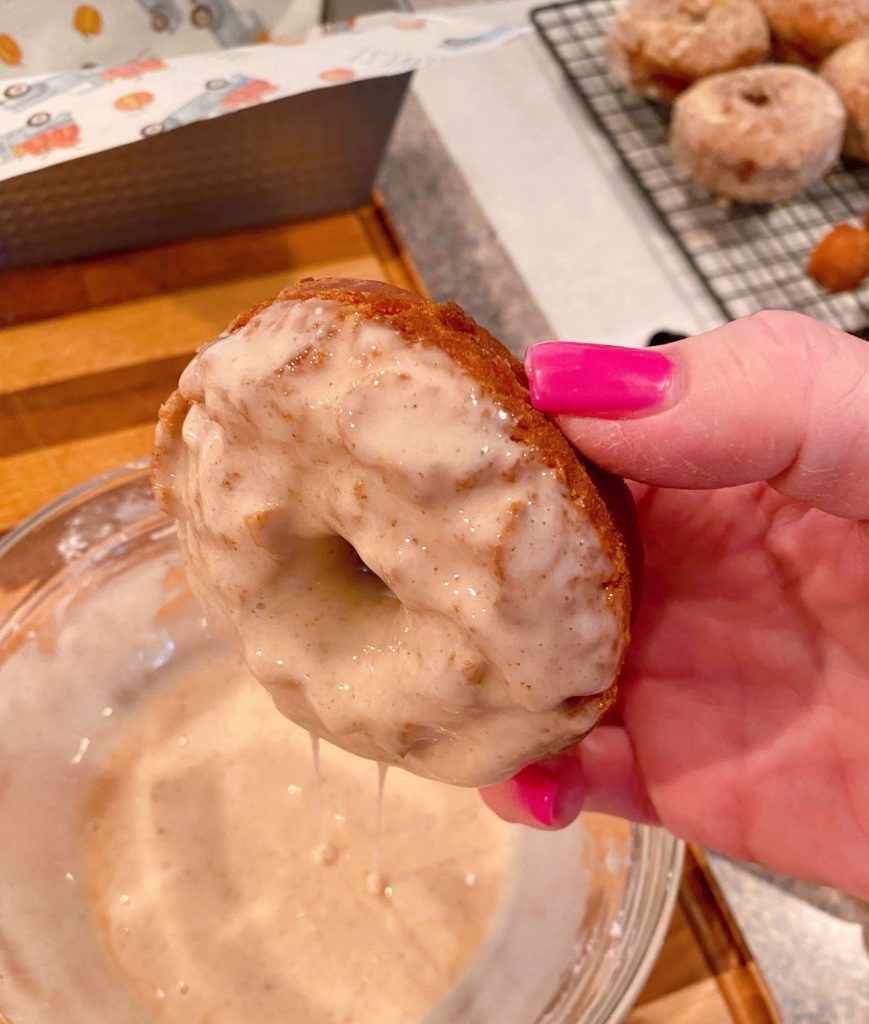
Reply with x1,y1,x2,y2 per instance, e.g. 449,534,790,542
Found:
414,0,721,345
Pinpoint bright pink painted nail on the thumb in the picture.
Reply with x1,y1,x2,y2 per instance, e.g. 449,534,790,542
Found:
525,341,674,419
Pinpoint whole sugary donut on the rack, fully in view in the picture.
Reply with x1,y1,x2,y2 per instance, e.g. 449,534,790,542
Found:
670,66,845,203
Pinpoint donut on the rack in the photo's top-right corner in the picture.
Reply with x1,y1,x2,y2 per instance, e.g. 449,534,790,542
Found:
757,0,869,67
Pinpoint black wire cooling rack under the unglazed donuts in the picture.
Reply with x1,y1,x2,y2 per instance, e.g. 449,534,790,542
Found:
531,0,869,333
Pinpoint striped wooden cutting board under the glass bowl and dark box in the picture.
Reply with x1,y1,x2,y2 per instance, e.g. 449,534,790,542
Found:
0,203,779,1024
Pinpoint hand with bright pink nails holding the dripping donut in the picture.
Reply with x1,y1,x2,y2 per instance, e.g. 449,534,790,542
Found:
483,312,869,897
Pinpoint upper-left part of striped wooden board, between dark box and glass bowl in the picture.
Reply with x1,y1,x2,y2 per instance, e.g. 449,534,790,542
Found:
0,206,418,530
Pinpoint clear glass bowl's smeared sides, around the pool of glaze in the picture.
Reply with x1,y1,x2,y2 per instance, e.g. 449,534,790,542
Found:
0,464,683,1024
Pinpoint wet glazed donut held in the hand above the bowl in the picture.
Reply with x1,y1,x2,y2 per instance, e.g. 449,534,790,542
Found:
154,280,636,785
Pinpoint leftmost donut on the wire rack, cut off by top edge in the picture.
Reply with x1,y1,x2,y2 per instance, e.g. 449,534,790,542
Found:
607,0,770,102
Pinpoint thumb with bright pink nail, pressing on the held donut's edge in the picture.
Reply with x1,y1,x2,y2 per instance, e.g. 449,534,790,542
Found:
526,312,869,519
